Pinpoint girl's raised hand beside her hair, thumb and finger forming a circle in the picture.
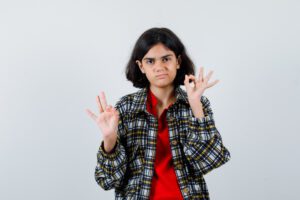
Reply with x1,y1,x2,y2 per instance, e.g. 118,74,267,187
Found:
184,67,219,101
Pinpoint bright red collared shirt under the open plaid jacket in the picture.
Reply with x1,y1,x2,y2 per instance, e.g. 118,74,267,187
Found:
147,89,183,200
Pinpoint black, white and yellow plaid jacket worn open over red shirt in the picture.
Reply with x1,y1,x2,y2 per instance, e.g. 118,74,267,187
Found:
95,86,230,200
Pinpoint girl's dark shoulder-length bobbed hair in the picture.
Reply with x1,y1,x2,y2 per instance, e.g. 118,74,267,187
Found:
125,27,195,88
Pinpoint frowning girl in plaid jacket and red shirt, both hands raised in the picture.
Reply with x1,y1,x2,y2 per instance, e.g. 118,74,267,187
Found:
87,28,230,200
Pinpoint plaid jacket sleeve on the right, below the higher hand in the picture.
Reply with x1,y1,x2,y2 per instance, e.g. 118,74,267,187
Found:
183,96,230,175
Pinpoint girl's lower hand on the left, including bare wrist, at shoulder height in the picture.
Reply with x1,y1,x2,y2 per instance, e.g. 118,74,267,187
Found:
86,92,119,147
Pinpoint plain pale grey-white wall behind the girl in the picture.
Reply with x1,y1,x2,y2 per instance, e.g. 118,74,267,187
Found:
0,0,300,200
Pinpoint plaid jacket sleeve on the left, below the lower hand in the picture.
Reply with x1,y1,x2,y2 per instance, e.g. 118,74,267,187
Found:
95,104,127,190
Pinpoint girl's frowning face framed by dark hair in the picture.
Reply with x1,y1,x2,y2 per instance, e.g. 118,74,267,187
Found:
136,43,180,88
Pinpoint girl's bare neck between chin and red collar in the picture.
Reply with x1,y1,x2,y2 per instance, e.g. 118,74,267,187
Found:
150,85,176,107
